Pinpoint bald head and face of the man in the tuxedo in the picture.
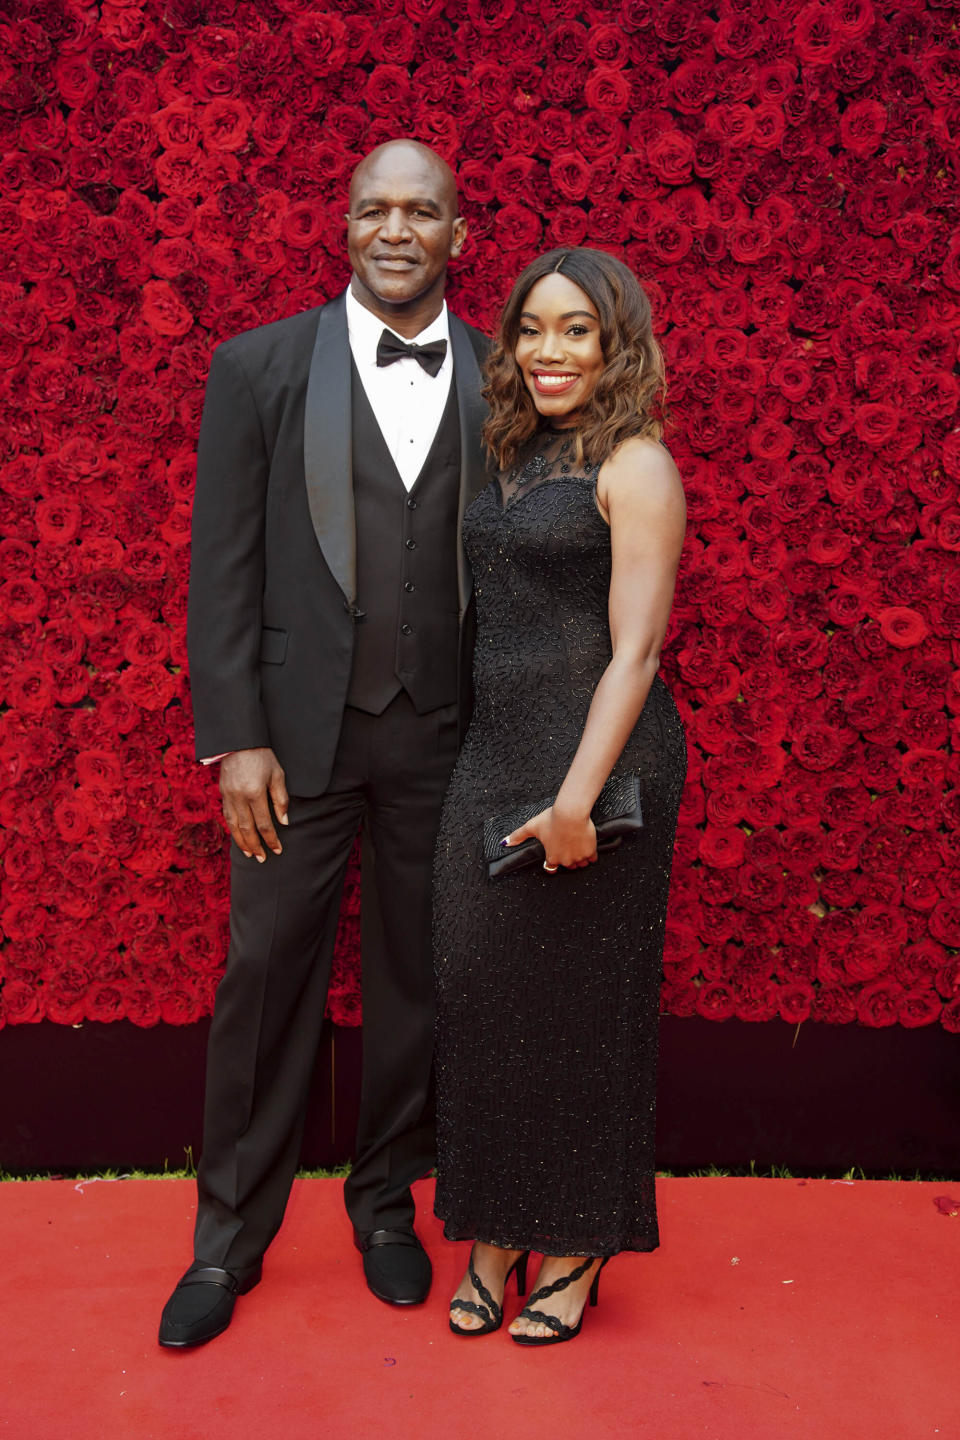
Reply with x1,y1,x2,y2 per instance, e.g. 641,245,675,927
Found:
347,145,466,307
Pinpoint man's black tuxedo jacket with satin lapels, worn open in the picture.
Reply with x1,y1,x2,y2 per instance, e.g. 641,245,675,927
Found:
187,286,489,795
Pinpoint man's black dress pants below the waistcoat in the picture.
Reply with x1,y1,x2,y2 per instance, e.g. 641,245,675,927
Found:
194,693,456,1270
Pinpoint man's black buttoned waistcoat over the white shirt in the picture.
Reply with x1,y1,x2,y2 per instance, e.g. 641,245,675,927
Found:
347,366,461,714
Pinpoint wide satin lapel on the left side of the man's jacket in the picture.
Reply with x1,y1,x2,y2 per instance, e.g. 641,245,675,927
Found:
304,295,357,605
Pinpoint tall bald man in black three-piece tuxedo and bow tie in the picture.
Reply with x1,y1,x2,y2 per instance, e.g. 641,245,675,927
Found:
160,141,486,1348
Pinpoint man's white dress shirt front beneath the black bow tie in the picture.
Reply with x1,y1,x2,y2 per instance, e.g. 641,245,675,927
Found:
347,291,453,490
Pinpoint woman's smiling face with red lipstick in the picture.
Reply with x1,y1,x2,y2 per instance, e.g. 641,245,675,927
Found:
514,272,606,426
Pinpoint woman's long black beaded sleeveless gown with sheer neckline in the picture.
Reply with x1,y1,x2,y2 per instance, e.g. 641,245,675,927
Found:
435,431,687,1256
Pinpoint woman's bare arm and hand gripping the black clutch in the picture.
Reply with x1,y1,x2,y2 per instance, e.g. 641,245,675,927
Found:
510,439,687,868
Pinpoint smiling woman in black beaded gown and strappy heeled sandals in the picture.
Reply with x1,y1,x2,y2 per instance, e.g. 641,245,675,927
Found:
435,249,687,1345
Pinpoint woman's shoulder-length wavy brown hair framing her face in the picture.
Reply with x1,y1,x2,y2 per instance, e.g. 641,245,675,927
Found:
484,246,666,469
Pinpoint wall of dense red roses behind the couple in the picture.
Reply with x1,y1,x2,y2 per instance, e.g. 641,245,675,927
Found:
0,0,960,1030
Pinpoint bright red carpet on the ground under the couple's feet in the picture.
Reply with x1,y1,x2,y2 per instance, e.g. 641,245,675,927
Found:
0,1179,960,1440
